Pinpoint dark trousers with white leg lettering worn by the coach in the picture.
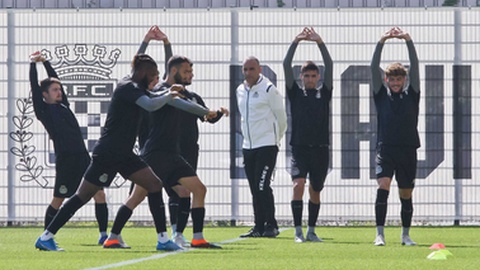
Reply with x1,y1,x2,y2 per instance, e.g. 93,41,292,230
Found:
243,146,278,232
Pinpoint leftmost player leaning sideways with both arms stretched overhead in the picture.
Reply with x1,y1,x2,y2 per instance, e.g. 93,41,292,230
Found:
30,51,108,244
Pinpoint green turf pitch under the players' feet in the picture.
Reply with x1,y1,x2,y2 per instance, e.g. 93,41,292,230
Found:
0,227,480,270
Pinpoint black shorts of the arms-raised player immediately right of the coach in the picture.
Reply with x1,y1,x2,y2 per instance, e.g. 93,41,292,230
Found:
290,146,330,192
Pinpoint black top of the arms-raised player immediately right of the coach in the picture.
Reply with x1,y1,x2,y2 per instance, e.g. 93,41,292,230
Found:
283,42,333,146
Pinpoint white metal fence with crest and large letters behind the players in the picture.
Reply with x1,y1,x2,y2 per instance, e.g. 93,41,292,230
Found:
0,8,480,224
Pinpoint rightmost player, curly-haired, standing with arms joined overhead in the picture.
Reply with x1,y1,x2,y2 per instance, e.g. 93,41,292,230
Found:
370,27,420,246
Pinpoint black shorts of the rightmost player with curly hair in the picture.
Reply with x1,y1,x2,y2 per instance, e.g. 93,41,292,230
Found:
375,145,417,188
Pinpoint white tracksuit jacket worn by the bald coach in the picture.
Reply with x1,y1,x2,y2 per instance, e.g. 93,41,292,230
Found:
237,74,287,149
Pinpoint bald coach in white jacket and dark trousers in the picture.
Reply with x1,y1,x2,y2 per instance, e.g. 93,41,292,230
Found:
237,56,287,237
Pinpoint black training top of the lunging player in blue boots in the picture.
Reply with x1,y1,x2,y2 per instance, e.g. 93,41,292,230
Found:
93,77,147,154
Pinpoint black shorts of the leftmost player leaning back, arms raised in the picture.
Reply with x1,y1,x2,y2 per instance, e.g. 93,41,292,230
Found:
53,152,90,198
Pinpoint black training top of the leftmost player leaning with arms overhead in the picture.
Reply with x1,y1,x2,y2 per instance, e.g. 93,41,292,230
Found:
30,61,87,156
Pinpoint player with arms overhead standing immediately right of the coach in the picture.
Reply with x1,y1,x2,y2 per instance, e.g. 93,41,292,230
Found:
283,27,333,243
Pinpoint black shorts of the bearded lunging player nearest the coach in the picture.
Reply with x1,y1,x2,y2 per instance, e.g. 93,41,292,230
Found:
142,151,197,191
